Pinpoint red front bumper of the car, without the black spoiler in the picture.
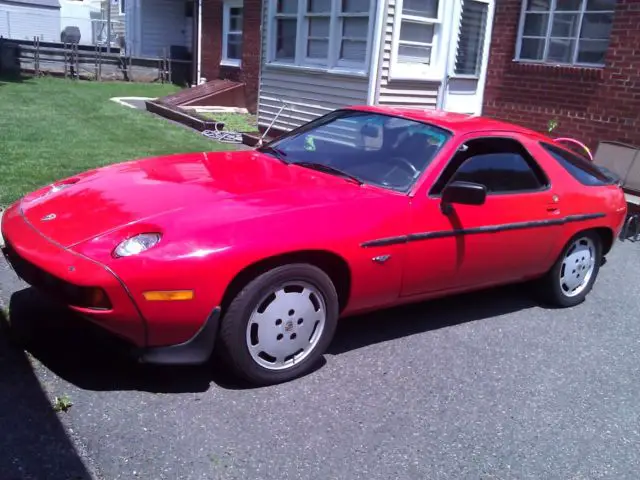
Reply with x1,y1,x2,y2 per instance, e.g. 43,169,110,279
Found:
1,205,147,347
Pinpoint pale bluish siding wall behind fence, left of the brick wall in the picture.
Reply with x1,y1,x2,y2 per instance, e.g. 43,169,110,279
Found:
140,0,187,57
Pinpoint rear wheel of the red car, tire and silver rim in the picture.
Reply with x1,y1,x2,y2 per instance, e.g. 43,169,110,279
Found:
539,231,602,308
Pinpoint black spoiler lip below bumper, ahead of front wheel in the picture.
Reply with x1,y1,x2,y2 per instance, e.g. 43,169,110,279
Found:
135,307,220,365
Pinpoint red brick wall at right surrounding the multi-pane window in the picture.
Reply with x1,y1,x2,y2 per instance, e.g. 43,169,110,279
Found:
483,0,640,148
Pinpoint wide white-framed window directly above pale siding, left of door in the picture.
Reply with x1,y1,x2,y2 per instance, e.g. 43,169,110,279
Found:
270,0,376,72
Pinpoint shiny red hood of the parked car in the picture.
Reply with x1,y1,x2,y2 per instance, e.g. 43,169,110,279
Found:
21,151,384,248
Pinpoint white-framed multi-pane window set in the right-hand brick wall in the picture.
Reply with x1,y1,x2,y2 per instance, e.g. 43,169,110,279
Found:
516,0,616,66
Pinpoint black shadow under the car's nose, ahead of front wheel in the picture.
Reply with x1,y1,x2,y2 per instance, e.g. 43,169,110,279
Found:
9,288,222,393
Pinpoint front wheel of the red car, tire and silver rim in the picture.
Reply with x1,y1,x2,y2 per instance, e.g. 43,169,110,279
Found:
218,264,339,386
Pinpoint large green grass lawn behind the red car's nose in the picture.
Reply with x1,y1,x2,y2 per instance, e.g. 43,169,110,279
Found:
0,78,233,205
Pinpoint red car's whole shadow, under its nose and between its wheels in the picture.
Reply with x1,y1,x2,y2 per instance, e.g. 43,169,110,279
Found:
10,286,536,393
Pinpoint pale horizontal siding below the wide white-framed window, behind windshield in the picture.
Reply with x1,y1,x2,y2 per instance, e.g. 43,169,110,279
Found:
258,0,369,131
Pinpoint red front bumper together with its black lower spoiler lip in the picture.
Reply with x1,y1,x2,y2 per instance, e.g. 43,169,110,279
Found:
0,202,220,365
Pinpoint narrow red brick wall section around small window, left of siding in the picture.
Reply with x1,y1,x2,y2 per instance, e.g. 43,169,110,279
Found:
201,0,262,113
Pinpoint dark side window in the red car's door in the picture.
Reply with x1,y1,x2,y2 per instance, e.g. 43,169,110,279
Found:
432,138,549,194
